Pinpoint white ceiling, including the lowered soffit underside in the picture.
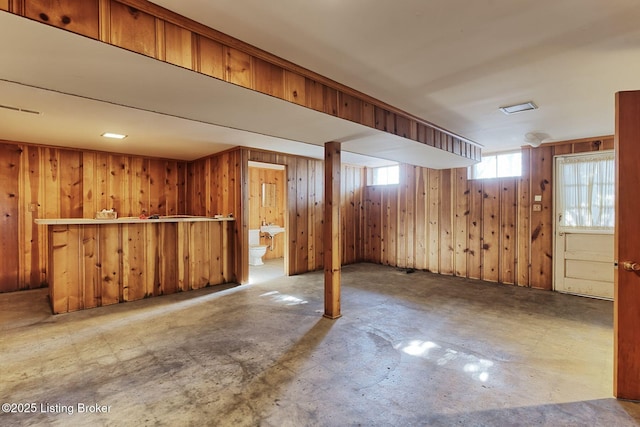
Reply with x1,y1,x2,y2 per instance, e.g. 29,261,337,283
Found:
0,0,640,167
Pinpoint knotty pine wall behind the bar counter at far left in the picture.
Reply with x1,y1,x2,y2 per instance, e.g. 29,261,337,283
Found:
0,141,186,292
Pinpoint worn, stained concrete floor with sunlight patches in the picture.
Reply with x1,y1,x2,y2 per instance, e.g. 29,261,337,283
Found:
0,264,640,427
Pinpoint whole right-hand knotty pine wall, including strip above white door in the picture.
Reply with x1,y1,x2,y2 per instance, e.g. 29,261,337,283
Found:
364,137,613,289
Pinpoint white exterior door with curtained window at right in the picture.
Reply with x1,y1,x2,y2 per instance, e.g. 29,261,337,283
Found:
554,151,615,299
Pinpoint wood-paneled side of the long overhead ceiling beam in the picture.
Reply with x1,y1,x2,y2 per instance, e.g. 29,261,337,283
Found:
0,0,481,159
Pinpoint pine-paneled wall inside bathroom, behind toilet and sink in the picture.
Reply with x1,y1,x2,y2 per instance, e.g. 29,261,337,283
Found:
249,167,287,259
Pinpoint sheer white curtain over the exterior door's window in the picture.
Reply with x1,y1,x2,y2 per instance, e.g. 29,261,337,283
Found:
556,152,615,230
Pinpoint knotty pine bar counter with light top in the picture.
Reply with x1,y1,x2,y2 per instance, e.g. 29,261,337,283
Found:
36,216,236,314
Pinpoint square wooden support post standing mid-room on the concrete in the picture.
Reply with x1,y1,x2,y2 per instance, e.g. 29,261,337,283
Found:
323,142,341,319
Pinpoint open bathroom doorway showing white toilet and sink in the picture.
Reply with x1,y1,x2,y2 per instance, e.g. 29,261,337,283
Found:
248,161,287,283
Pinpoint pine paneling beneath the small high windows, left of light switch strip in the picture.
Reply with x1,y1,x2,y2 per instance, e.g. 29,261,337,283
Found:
363,169,518,283
